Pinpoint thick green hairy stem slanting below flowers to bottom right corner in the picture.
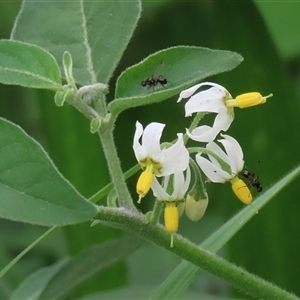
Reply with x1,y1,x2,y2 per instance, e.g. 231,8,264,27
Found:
97,207,299,299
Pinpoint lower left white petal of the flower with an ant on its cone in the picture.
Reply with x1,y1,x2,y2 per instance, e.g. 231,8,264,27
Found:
196,154,230,183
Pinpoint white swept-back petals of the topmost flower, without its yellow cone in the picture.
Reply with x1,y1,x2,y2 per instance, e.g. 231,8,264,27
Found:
177,82,234,142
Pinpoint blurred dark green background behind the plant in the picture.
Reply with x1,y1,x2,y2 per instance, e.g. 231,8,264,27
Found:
0,1,300,299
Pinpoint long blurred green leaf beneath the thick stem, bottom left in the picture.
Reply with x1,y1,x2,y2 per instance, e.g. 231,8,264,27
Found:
12,236,143,299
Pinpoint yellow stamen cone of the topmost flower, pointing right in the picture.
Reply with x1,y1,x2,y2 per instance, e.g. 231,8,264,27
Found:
226,92,273,108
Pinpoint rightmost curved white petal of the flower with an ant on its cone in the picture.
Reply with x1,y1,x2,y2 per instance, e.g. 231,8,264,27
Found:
218,134,244,175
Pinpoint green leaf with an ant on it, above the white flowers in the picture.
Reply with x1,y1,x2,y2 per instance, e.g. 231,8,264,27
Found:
109,46,243,114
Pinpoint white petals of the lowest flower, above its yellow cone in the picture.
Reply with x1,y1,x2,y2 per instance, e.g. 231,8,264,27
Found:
151,167,191,201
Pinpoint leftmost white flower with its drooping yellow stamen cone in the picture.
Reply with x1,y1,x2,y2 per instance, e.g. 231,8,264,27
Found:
133,122,189,202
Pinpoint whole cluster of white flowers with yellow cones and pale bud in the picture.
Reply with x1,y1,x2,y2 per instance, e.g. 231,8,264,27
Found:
133,82,272,246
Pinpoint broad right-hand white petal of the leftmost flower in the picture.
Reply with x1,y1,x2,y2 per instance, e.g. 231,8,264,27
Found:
158,133,189,176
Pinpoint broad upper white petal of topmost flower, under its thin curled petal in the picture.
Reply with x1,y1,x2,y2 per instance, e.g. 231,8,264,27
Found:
184,87,227,117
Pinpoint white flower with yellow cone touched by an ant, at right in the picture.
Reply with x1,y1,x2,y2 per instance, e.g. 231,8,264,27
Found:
196,134,252,204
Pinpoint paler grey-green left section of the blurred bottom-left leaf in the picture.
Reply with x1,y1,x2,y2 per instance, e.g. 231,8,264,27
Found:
10,259,68,300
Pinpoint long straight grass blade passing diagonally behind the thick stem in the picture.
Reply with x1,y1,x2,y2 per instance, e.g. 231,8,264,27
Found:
151,166,300,299
